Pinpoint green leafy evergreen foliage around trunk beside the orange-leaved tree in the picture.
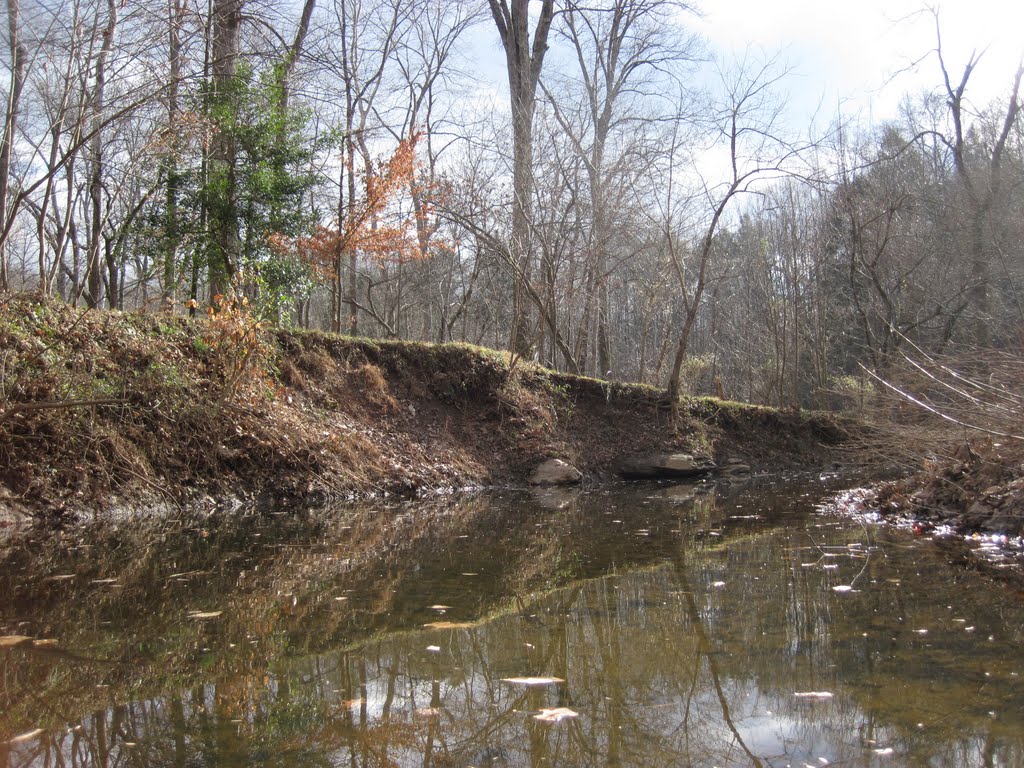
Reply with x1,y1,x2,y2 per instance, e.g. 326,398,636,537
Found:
146,63,321,322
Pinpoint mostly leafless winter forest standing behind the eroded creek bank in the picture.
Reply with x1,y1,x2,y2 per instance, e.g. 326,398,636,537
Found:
0,0,1024,408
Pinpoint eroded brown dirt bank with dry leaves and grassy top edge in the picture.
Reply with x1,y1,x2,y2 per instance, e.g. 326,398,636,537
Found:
0,297,854,516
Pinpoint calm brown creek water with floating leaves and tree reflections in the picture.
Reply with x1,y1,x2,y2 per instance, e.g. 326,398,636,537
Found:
0,483,1024,767
